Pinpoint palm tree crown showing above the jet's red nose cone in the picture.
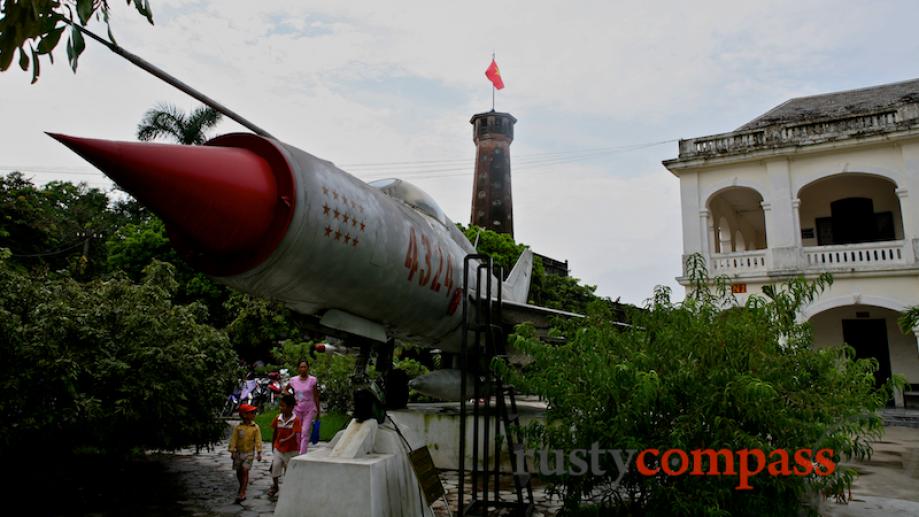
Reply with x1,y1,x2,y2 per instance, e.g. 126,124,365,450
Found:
137,104,221,145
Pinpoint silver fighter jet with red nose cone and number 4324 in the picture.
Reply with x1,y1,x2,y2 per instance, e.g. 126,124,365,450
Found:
49,27,578,418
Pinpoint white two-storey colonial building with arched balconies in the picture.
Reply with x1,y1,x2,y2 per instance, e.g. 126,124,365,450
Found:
664,80,919,407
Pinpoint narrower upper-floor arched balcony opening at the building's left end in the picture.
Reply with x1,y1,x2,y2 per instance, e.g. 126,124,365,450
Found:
707,187,768,274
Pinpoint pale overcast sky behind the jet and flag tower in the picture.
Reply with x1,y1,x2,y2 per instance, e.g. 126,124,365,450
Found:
0,0,919,303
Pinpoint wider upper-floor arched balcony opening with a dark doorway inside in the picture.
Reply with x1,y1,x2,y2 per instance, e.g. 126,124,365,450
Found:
798,173,907,270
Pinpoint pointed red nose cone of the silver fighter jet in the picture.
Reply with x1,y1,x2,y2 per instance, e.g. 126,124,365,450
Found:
49,133,293,275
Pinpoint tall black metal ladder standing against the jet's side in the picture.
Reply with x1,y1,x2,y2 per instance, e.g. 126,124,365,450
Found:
457,254,535,517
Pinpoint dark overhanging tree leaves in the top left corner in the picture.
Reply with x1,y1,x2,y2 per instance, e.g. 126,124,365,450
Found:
0,0,153,84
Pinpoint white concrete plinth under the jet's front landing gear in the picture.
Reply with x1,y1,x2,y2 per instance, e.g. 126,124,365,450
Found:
275,422,433,517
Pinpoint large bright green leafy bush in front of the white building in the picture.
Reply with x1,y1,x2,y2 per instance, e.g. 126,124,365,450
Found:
504,258,902,515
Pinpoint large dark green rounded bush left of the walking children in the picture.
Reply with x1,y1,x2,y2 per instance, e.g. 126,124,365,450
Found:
0,253,236,457
